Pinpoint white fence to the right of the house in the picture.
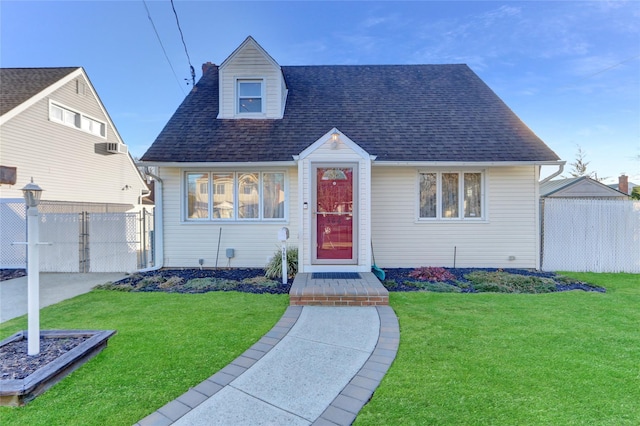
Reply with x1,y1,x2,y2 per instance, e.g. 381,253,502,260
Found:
542,198,640,273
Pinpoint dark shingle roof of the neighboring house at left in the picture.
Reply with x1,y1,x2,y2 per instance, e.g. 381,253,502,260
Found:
0,67,79,115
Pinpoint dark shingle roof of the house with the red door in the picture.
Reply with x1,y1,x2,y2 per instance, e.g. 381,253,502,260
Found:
142,65,559,162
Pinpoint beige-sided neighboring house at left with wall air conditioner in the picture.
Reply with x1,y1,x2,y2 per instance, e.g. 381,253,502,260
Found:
0,67,148,270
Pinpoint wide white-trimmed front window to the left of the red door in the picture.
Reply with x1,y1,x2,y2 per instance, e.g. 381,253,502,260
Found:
185,171,286,221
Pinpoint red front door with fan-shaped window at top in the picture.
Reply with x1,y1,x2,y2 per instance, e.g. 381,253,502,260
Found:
314,166,357,264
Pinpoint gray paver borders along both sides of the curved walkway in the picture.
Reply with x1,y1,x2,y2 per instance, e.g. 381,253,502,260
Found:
134,306,400,426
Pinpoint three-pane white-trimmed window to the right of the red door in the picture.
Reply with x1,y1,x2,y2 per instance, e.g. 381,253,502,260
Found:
418,171,484,220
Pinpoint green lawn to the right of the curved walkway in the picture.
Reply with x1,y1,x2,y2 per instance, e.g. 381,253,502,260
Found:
355,273,640,426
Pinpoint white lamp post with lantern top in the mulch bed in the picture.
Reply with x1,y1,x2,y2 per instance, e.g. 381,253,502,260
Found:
22,178,42,355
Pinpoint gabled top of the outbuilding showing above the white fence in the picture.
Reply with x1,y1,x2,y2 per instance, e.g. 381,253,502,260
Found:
540,176,629,200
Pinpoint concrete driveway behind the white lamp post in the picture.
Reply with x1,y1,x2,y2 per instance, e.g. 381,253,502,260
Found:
0,272,126,323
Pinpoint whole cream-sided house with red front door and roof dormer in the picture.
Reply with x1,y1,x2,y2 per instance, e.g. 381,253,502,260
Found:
142,37,564,272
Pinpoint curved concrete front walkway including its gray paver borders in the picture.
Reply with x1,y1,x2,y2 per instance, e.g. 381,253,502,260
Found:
137,306,399,426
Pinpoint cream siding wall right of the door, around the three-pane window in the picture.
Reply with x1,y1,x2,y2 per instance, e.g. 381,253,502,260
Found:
371,163,538,268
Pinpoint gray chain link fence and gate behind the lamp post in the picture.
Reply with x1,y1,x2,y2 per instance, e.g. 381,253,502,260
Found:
0,200,154,272
